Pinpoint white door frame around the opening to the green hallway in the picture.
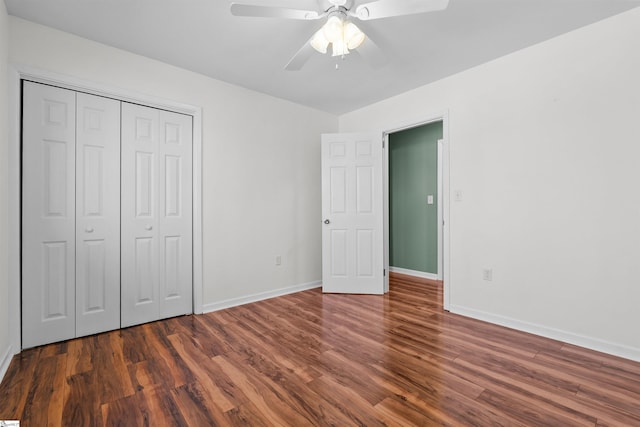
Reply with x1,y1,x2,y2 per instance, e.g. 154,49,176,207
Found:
381,110,451,311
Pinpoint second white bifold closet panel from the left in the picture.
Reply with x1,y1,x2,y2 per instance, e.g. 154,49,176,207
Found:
76,93,120,336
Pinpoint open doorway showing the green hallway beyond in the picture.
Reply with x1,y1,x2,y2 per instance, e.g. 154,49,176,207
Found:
385,115,449,309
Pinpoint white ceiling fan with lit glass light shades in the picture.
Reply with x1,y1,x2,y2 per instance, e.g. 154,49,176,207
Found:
231,0,449,71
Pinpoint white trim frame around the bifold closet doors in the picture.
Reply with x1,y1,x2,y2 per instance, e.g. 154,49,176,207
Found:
7,64,203,354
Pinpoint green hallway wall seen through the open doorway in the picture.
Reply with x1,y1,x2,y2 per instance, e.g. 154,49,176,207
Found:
389,122,442,274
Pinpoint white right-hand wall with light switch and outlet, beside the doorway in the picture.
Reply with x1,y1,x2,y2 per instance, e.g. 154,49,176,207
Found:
340,9,640,360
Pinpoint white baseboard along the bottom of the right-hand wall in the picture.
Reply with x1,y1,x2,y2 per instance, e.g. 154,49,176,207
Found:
450,304,640,362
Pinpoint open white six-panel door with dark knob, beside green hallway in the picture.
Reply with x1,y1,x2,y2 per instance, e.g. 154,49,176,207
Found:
322,133,386,294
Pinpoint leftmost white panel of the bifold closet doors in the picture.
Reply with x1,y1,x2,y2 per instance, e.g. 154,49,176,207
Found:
22,82,76,348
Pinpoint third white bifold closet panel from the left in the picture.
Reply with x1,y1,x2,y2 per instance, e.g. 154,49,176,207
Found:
121,102,160,327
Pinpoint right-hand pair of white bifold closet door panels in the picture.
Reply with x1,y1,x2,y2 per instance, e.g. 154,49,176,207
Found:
121,103,193,327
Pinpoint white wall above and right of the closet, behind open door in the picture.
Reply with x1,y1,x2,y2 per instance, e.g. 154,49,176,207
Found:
9,17,338,310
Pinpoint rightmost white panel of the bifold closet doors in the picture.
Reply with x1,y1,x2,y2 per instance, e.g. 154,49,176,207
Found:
158,111,193,318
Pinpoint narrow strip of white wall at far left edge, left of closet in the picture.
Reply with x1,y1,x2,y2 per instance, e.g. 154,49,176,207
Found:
0,1,12,378
